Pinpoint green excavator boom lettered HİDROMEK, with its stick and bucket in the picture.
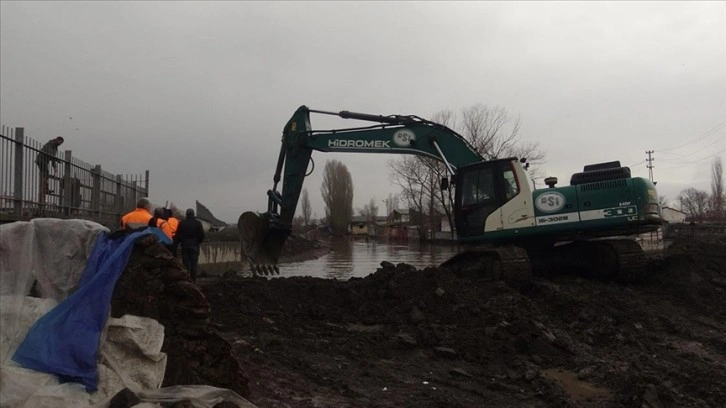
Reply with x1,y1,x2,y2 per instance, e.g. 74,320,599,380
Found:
238,106,484,274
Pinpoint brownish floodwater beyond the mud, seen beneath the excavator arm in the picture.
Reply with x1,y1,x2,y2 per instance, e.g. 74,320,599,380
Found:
279,237,459,280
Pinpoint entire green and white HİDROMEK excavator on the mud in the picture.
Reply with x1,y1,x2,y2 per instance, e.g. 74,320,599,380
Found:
238,106,662,281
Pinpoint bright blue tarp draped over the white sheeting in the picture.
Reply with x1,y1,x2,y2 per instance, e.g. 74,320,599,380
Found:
13,228,170,391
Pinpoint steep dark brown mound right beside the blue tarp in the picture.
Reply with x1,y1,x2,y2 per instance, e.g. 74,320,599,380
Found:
111,236,249,397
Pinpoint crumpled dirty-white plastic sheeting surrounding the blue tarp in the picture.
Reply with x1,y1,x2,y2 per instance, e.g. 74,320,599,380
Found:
0,218,254,408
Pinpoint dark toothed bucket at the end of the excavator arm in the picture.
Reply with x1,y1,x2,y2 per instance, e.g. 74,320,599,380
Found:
237,211,290,275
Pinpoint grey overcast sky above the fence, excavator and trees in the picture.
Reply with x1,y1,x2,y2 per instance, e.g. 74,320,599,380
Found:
0,1,726,223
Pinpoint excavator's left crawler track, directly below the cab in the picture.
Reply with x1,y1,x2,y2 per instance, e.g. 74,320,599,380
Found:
441,246,532,282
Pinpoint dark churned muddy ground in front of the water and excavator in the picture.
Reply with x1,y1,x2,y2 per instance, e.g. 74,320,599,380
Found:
114,233,726,408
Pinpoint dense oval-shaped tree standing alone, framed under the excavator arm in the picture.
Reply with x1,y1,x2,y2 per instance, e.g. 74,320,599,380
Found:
320,160,353,234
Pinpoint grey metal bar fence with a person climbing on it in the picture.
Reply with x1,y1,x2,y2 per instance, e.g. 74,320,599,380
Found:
0,126,149,228
